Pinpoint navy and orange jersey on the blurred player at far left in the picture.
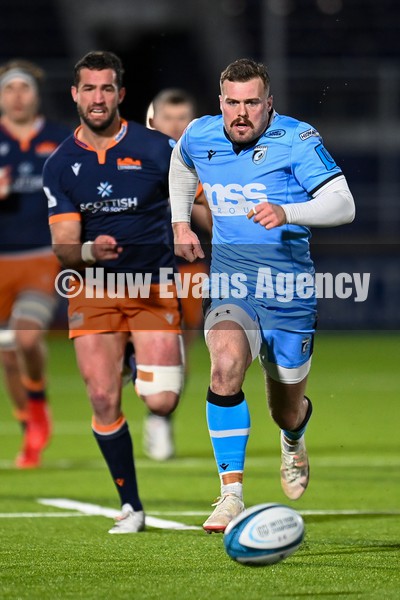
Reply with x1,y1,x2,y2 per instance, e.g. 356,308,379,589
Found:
0,118,71,254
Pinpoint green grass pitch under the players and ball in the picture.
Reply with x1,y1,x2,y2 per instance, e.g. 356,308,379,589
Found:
0,332,400,600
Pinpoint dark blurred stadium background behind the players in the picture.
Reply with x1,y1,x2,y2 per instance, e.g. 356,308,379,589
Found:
0,0,400,329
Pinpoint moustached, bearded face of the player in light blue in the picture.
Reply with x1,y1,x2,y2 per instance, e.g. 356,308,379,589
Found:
220,78,272,144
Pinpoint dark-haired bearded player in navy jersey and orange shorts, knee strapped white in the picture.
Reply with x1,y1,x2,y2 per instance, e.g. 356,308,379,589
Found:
43,51,183,534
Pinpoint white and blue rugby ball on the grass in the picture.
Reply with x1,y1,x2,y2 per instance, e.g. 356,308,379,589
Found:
224,503,304,565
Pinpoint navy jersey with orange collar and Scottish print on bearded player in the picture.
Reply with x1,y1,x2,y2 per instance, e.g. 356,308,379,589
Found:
43,120,175,283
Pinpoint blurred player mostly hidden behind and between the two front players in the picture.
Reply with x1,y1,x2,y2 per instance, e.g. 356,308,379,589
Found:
133,88,212,461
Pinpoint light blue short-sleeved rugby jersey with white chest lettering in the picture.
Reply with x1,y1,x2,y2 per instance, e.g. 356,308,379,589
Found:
181,113,342,304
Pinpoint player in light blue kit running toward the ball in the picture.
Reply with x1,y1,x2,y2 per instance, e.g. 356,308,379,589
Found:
170,59,355,533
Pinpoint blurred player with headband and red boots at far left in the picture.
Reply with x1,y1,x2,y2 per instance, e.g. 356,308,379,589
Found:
0,60,70,468
